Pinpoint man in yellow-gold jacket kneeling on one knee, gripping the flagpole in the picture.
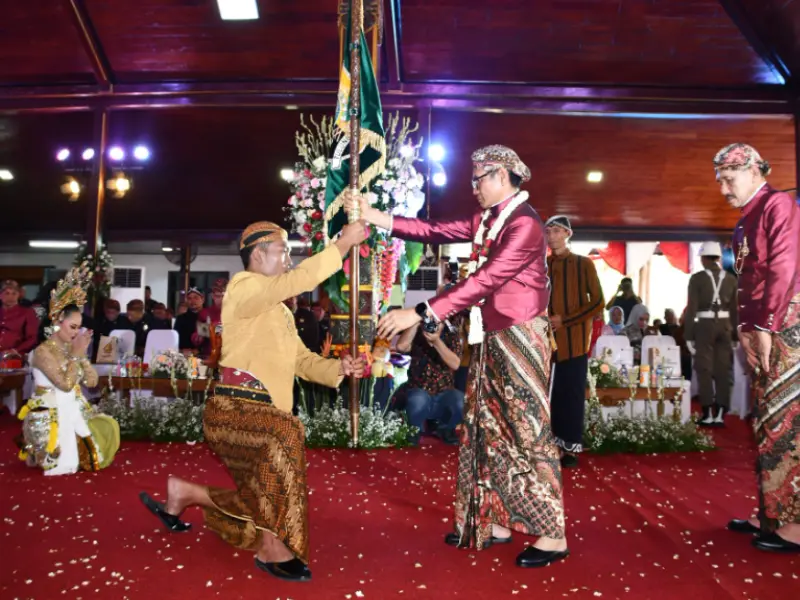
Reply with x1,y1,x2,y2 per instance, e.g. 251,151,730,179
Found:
140,221,365,581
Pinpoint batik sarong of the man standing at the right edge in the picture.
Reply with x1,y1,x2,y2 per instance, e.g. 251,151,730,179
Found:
755,296,800,531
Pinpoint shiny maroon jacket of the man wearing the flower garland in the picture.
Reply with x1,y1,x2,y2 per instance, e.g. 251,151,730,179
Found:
392,198,550,331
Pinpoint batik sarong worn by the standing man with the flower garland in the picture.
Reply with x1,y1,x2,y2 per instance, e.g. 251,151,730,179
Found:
455,317,564,550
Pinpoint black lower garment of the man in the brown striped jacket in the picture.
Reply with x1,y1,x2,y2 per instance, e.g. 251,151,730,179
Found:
550,354,589,452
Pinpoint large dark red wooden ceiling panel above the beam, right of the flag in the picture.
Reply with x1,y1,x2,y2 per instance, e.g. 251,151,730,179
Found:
402,0,782,87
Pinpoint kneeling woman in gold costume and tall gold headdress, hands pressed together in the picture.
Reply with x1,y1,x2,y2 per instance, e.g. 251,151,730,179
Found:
19,269,119,475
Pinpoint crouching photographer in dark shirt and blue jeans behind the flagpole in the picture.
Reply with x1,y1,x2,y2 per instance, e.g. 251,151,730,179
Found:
397,317,464,444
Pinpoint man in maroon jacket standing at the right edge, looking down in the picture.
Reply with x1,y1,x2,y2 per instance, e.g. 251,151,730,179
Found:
714,144,800,553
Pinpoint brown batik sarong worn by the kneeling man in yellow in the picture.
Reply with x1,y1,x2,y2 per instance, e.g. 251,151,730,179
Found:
203,384,308,564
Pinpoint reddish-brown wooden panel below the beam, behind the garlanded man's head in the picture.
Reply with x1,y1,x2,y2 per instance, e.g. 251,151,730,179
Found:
424,112,795,232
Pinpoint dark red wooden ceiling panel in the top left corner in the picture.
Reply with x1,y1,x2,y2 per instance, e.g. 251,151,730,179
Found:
0,0,94,85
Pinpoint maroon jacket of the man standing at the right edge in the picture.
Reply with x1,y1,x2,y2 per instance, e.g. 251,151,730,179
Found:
733,185,800,332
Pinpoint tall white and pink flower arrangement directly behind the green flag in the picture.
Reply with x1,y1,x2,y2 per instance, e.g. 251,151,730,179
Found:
285,114,425,312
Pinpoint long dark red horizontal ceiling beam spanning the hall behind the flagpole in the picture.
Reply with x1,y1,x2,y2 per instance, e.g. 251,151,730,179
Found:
0,80,794,116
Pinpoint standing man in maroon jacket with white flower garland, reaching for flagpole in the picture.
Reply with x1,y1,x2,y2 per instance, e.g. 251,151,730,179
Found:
345,146,569,567
